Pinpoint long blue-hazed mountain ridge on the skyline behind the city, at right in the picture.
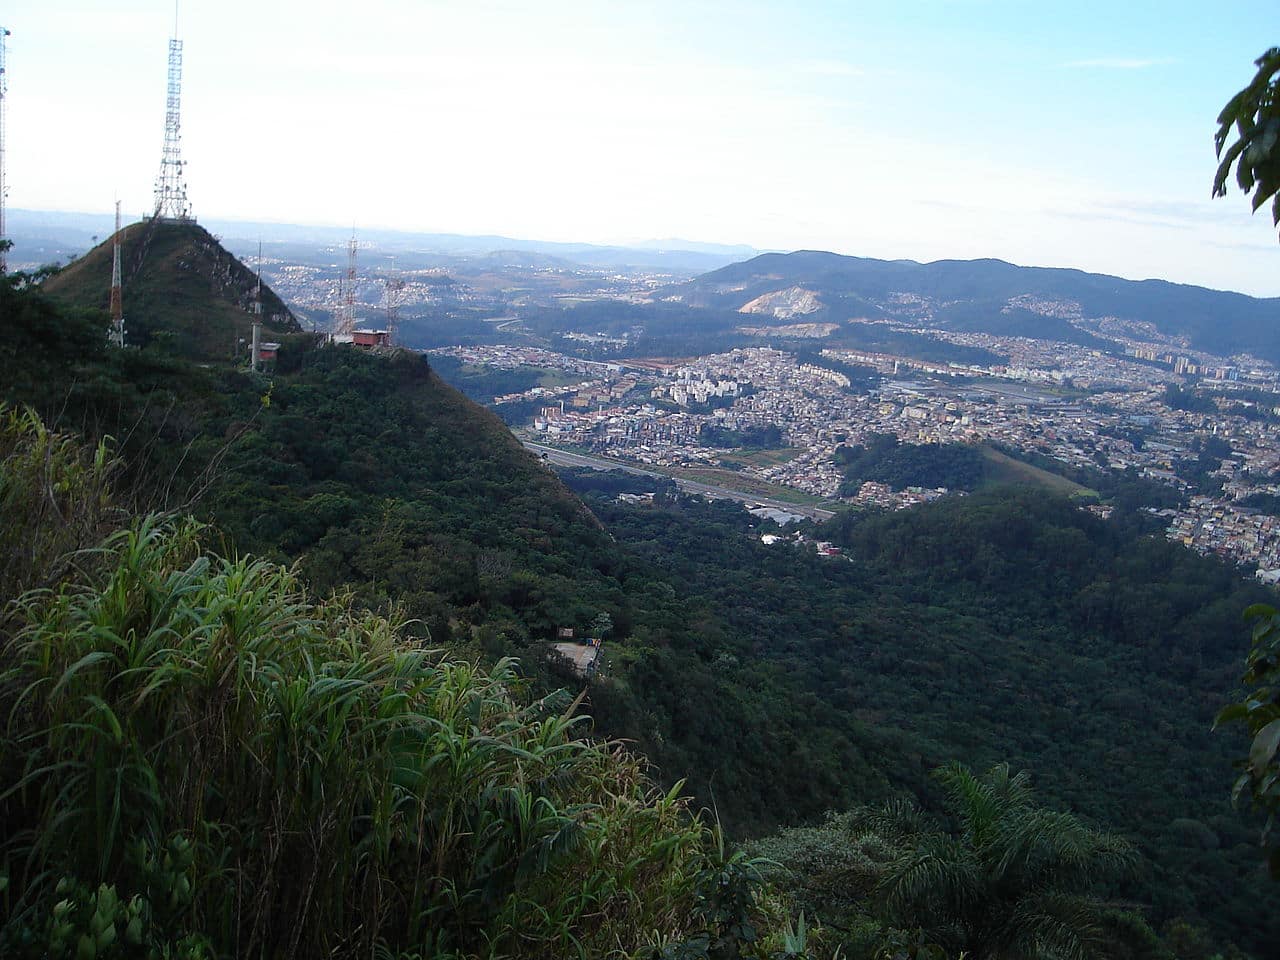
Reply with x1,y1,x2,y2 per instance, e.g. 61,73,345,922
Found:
664,250,1280,362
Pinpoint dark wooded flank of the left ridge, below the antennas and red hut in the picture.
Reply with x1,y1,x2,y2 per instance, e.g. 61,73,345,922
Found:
0,272,622,658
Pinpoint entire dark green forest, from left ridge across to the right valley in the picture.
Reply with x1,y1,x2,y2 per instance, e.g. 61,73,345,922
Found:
0,259,1280,956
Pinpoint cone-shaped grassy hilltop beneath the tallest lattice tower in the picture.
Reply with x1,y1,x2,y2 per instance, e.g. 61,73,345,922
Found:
44,220,301,360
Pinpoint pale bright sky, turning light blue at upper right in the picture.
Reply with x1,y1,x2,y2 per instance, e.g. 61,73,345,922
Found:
0,0,1280,296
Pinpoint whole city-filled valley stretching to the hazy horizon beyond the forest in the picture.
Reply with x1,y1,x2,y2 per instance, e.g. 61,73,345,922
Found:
15,213,1280,582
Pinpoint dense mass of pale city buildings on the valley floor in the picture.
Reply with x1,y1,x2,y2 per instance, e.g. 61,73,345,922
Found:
437,334,1280,577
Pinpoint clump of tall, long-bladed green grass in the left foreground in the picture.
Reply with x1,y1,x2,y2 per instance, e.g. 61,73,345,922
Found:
3,517,703,956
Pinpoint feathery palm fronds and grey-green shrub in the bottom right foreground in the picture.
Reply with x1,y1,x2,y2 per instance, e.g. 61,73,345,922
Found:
751,764,1167,960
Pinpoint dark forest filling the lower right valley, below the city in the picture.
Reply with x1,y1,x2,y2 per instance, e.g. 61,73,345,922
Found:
573,475,1280,945
